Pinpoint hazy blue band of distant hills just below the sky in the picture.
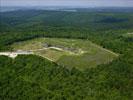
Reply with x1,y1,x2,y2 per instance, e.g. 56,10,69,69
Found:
0,6,133,12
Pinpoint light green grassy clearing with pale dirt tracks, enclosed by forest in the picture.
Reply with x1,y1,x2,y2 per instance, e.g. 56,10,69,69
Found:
12,38,118,70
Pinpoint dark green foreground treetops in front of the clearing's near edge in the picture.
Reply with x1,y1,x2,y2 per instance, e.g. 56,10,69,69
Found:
0,55,133,100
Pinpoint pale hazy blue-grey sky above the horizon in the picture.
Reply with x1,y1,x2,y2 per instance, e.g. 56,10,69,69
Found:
0,0,133,7
